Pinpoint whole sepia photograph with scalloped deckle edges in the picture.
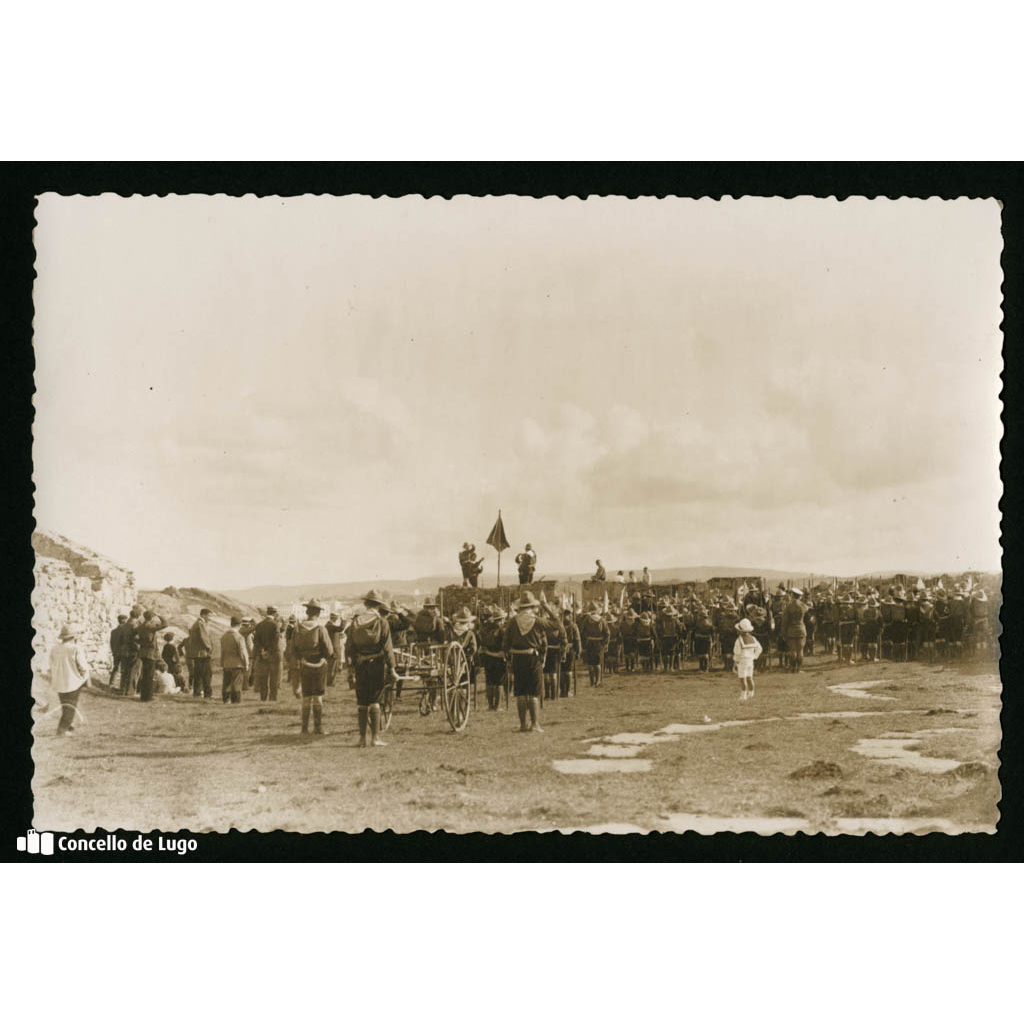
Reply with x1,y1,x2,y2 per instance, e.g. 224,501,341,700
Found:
31,193,1004,837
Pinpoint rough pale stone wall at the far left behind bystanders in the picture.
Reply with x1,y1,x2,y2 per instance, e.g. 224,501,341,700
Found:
32,530,136,676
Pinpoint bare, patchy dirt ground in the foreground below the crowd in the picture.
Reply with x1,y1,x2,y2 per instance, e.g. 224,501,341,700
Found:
34,655,1000,834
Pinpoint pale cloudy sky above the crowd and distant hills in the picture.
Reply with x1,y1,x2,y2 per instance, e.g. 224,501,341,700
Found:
35,196,1001,589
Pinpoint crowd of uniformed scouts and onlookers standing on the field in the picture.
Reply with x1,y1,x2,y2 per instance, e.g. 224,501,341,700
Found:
44,573,996,746
